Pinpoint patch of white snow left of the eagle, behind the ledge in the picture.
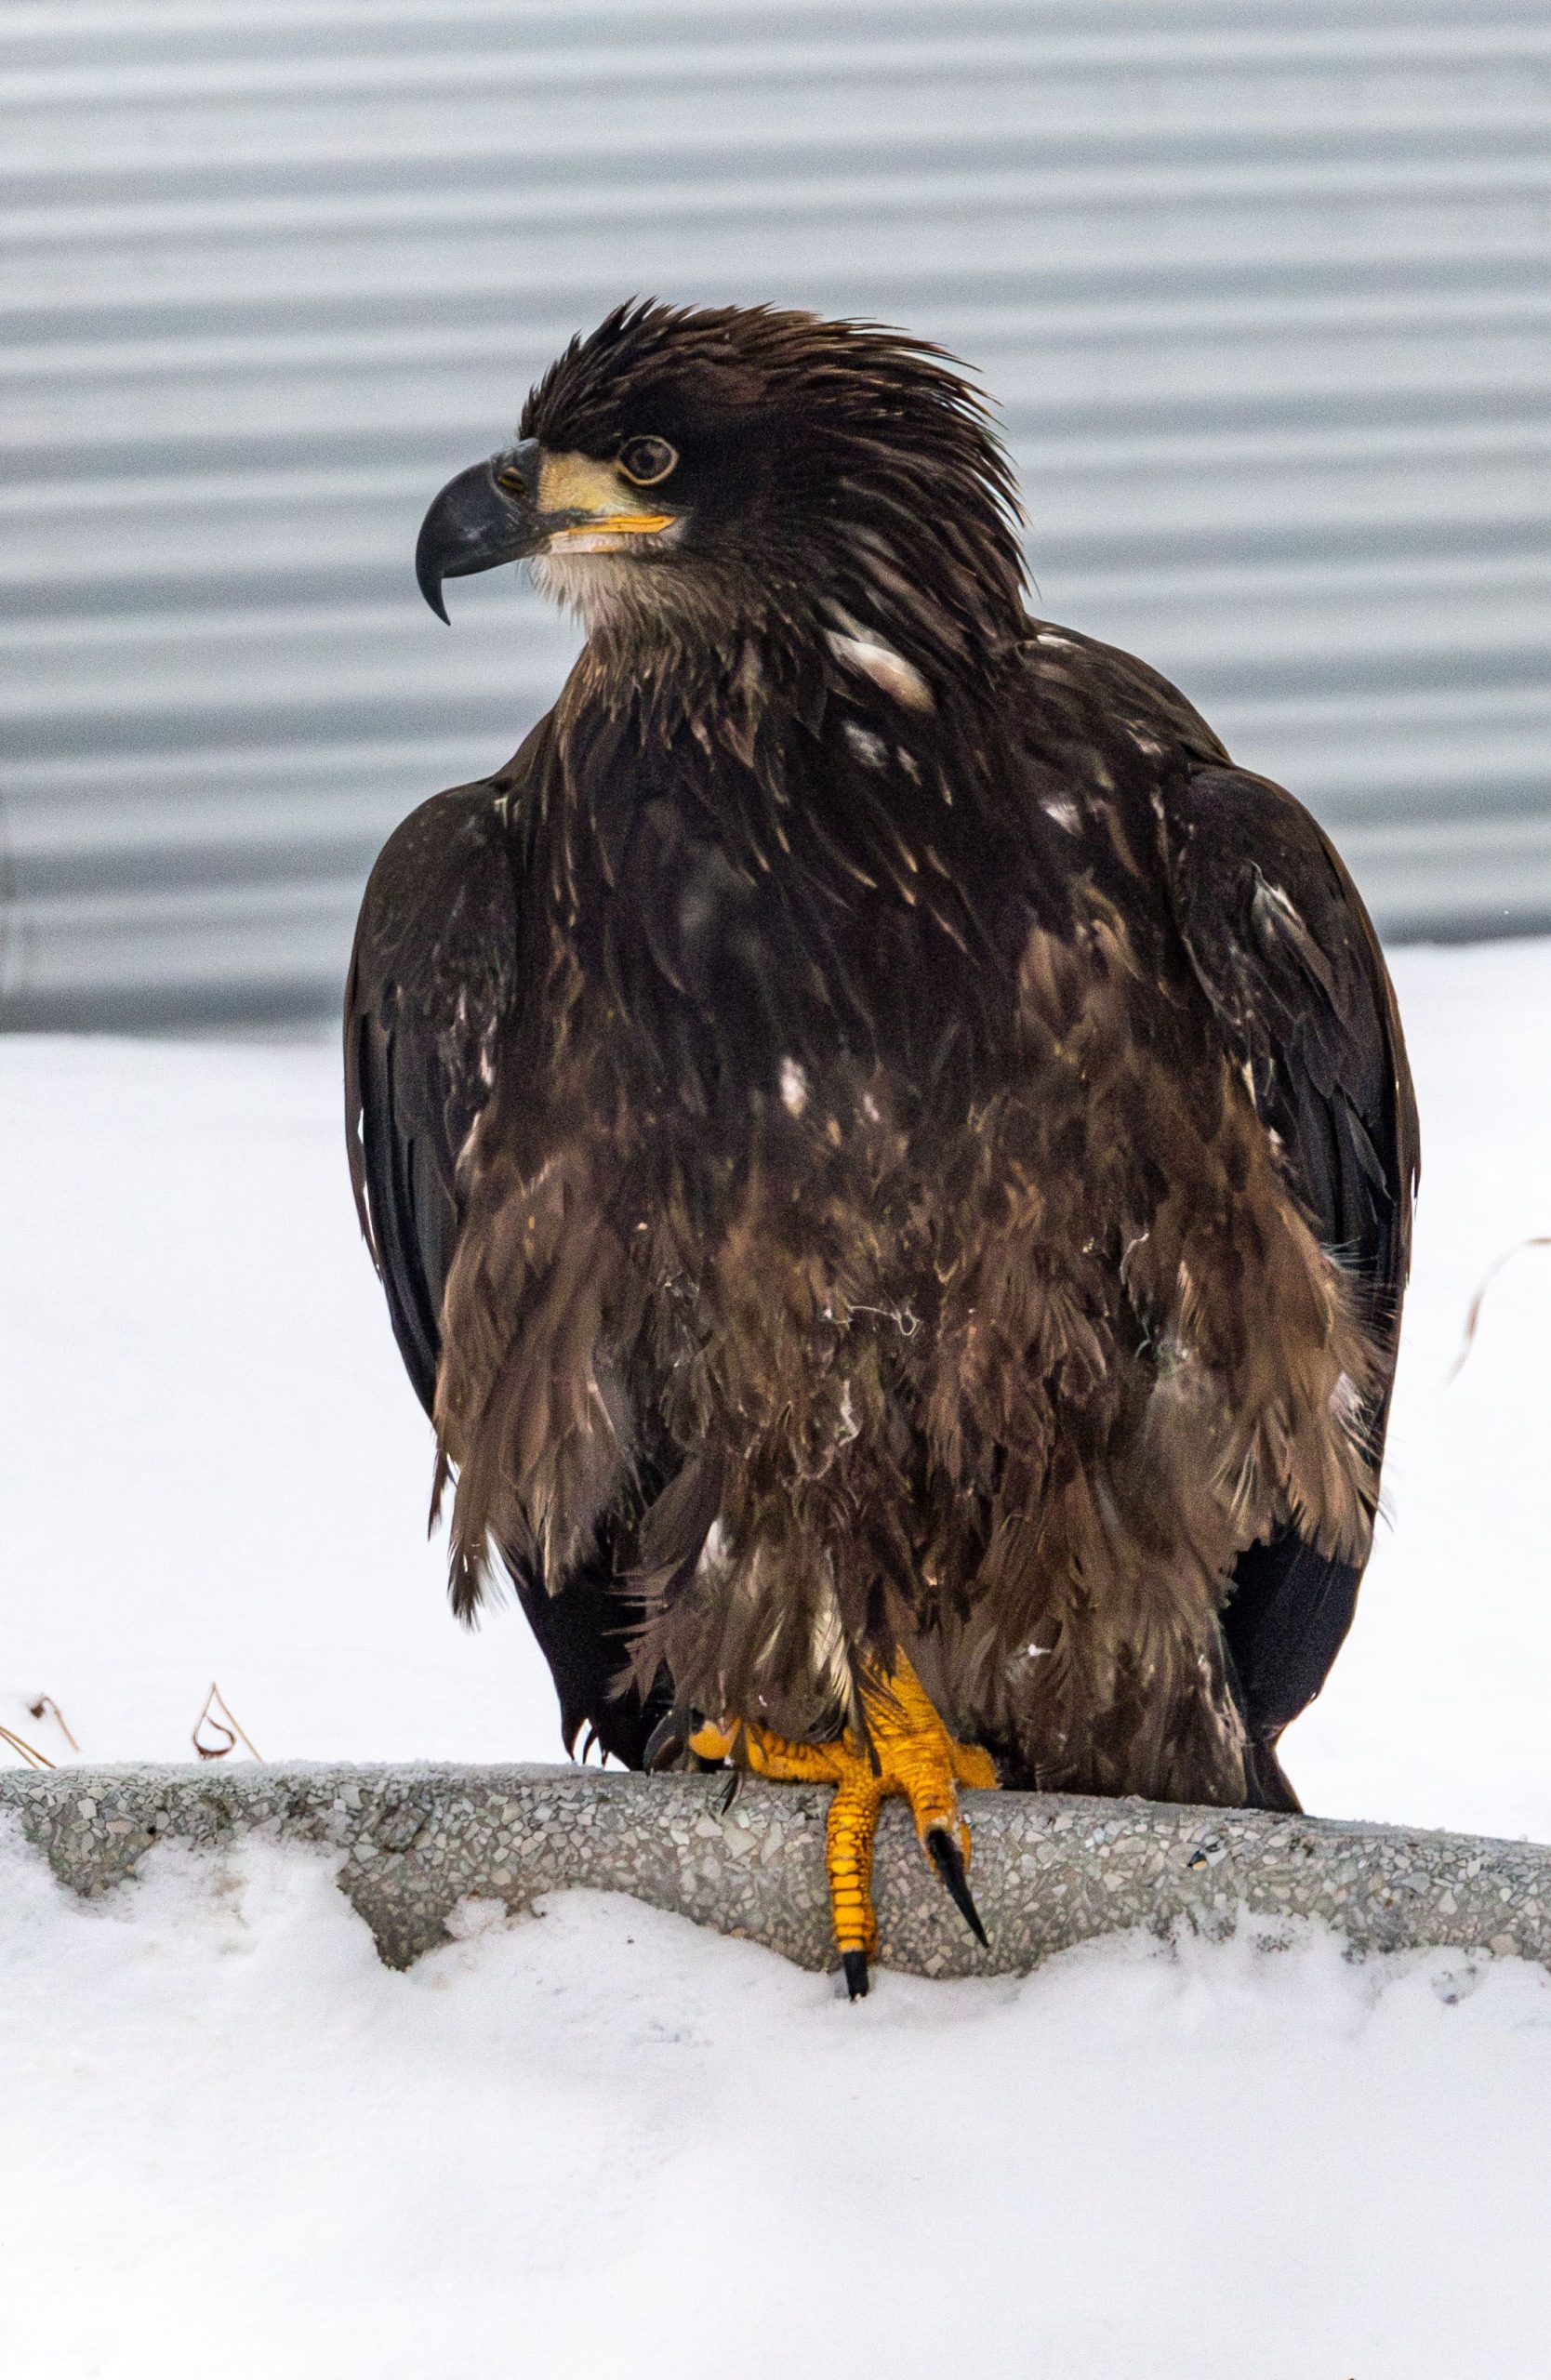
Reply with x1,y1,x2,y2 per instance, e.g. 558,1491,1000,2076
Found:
0,1038,559,1761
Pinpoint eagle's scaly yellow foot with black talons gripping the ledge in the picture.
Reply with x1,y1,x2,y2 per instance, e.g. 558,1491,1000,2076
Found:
690,1654,997,1999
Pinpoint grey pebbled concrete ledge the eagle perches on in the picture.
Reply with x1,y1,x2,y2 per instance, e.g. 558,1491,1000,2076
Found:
0,1766,1551,1976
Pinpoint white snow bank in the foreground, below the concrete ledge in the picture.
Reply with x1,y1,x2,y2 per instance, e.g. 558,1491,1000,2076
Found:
0,1844,1551,2380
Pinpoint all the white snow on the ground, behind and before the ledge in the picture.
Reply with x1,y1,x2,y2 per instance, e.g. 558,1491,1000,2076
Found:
0,943,1551,2380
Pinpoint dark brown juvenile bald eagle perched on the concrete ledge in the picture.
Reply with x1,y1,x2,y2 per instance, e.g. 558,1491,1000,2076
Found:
345,305,1418,1992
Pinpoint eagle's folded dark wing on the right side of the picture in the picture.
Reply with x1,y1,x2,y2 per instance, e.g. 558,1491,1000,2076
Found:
1163,769,1418,1806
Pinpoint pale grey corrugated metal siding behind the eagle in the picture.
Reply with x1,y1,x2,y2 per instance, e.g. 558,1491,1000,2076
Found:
0,0,1551,1024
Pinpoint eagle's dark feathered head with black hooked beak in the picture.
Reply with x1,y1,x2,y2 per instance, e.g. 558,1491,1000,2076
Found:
417,305,1023,685
